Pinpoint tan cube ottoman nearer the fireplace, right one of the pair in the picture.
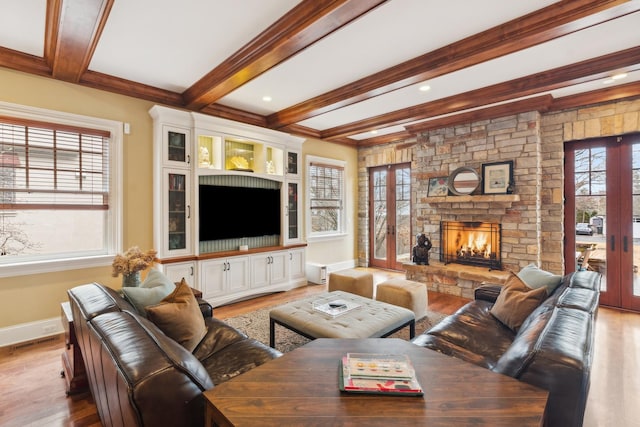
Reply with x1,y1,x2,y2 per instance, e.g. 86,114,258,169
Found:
376,278,427,320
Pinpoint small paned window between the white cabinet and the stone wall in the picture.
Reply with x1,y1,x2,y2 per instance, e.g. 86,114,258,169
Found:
307,156,345,238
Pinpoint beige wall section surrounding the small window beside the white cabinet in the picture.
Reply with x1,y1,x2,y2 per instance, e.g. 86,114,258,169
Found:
302,139,358,266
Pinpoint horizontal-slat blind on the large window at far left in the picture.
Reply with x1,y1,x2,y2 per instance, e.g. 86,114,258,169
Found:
0,116,110,210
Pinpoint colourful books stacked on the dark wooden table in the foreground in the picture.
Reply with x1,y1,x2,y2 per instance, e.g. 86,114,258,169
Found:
339,353,423,396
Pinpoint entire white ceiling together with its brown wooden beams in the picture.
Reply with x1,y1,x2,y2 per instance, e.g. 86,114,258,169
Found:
0,0,640,146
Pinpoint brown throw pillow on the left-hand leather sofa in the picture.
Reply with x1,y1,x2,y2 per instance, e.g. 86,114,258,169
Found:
147,279,207,352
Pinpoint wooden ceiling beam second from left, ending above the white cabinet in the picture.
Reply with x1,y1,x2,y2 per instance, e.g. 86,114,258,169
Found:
183,0,386,110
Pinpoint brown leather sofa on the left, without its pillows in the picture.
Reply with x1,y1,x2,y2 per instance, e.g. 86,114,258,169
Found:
68,283,281,427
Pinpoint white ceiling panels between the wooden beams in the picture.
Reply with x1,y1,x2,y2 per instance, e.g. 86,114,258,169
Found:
0,0,640,145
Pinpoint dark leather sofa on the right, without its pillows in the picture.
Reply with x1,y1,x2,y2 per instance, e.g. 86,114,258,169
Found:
413,271,601,427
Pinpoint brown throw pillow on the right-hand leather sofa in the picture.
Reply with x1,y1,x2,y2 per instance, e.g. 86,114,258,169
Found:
491,273,547,332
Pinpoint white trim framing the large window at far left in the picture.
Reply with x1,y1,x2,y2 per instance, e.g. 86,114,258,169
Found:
0,101,123,278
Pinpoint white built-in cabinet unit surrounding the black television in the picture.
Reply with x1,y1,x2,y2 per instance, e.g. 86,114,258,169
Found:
149,106,306,306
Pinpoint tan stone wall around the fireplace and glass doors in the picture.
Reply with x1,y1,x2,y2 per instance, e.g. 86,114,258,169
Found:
358,99,640,293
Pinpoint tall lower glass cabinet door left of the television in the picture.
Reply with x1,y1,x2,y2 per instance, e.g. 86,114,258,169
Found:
165,172,191,253
